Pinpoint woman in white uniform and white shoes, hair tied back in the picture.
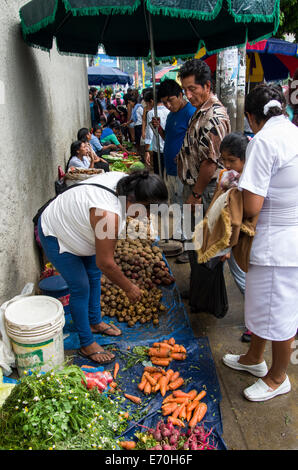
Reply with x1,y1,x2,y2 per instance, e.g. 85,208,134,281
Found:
223,85,298,401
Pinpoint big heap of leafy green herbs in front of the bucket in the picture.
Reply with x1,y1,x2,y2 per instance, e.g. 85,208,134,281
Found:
0,365,127,450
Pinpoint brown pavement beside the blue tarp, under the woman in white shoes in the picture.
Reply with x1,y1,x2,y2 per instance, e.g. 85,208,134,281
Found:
167,257,298,450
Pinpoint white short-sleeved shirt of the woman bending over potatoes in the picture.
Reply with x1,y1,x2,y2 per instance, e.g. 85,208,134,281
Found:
41,172,127,256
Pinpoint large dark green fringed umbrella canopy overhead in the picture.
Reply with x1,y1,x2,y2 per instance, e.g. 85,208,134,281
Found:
20,0,279,58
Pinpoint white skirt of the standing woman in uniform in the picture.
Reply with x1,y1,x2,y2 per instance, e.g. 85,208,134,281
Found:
245,264,298,341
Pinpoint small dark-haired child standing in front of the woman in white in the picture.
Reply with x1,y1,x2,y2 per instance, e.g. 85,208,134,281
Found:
218,132,251,342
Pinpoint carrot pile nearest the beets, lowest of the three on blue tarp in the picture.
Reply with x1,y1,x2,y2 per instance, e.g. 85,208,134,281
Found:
161,390,207,428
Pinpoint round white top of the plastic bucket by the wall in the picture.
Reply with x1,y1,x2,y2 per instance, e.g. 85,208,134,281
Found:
5,295,64,329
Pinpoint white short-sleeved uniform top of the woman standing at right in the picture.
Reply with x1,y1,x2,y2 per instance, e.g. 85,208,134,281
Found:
238,116,298,266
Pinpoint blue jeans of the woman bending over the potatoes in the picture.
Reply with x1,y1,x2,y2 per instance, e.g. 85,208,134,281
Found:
38,218,101,347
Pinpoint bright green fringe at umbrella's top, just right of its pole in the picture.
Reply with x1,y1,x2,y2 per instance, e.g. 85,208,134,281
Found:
145,0,223,20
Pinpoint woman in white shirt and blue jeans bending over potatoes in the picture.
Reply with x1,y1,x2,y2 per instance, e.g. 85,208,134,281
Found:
38,171,168,364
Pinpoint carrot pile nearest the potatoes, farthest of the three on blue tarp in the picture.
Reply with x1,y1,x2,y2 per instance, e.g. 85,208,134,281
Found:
148,338,186,367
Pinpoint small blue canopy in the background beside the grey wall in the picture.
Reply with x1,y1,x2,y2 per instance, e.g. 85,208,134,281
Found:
88,65,133,86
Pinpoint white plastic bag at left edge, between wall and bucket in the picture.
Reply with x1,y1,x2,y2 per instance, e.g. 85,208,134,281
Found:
0,282,34,376
